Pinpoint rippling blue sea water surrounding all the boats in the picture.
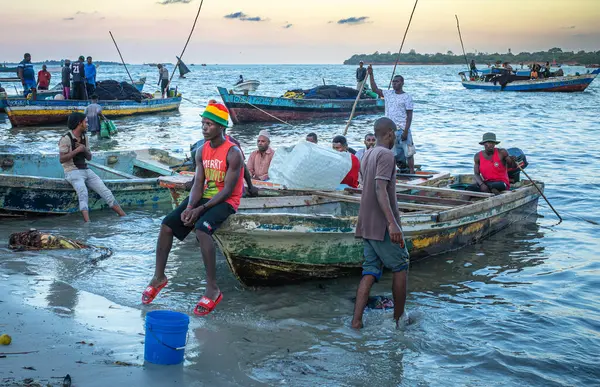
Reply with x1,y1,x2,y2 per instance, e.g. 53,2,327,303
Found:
0,65,600,386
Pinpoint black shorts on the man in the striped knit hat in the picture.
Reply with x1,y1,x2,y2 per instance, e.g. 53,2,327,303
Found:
162,198,235,241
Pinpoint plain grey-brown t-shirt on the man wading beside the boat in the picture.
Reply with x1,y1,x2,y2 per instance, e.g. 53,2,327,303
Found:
356,146,400,241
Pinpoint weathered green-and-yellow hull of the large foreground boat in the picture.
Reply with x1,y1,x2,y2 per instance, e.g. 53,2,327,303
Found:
215,186,539,286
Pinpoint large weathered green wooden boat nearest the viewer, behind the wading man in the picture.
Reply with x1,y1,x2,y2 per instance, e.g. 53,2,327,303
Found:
215,176,543,286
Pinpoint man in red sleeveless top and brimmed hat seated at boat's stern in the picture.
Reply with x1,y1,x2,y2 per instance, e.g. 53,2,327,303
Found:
467,133,517,194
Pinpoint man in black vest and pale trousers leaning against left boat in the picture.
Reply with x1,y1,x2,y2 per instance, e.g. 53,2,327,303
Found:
58,112,125,222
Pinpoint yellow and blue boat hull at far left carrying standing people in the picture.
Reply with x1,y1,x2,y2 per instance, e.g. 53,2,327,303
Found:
6,97,181,126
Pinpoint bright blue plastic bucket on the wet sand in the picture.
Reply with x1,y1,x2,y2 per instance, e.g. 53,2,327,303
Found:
144,310,190,365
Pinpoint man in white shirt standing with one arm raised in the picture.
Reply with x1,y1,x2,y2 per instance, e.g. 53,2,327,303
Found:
367,65,417,173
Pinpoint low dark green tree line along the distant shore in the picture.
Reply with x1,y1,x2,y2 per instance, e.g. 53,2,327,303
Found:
344,47,600,65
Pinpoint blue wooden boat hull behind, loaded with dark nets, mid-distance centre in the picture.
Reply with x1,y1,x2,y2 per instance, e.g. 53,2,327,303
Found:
217,87,385,124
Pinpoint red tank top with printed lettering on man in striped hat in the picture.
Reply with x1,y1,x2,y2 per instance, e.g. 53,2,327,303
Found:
202,140,244,211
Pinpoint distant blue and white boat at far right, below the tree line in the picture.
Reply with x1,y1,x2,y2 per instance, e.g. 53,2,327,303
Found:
458,69,600,92
